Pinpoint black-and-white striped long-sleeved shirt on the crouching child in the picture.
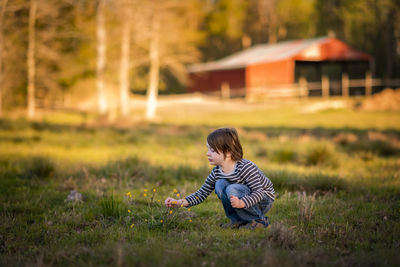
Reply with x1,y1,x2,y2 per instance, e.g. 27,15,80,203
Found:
186,159,275,208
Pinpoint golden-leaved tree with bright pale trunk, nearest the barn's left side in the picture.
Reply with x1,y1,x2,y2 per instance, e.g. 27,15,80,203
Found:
141,0,203,120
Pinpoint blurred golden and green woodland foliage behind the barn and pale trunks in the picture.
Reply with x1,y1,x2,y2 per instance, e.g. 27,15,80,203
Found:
0,0,400,109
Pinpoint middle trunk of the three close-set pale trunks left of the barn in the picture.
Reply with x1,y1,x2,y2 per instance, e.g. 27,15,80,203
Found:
120,1,131,116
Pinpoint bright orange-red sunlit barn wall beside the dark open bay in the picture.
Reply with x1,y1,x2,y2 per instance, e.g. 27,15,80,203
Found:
246,59,294,88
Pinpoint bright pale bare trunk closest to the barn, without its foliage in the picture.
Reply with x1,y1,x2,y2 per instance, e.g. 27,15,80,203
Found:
146,12,160,120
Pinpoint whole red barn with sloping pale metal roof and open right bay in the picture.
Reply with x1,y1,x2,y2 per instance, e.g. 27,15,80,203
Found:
188,37,372,95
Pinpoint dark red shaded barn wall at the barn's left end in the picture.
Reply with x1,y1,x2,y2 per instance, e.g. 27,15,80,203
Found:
188,69,245,92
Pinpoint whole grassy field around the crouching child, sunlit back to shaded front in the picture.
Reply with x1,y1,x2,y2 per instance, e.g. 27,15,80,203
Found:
0,99,400,266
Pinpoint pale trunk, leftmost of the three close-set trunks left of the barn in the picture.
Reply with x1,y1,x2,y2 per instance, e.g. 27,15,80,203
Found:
96,0,108,114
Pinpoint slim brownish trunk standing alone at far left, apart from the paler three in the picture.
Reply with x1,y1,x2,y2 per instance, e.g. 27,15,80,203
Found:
27,0,37,118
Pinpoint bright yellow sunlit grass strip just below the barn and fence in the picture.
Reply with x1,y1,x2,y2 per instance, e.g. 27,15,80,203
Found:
162,103,400,130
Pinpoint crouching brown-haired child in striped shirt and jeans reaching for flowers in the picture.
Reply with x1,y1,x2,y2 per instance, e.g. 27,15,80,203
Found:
165,128,275,229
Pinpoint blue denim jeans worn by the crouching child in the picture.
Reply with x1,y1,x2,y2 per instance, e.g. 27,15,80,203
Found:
215,179,274,224
